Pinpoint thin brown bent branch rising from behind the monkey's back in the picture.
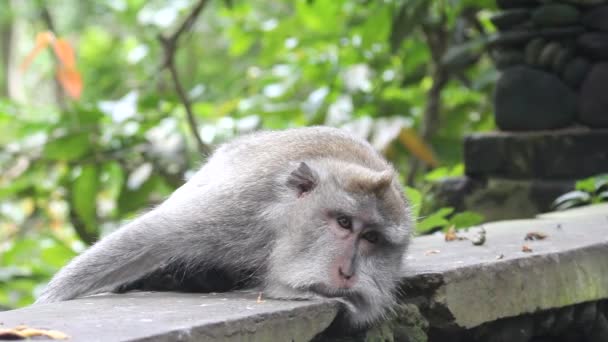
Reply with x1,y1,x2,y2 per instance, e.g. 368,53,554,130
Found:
158,0,211,155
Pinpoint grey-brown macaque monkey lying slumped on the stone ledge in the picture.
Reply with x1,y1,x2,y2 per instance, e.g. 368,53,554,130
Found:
36,126,412,327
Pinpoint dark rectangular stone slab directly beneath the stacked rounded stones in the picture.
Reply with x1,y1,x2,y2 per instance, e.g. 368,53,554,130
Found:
464,128,608,180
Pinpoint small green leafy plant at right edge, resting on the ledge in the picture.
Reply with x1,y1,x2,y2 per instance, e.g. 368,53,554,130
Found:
553,174,608,210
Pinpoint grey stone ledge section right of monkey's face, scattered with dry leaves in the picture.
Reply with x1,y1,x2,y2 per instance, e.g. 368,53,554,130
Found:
403,204,608,329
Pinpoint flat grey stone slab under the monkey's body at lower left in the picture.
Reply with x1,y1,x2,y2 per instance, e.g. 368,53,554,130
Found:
0,291,338,342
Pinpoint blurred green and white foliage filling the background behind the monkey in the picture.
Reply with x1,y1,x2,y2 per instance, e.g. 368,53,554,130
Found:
0,0,496,307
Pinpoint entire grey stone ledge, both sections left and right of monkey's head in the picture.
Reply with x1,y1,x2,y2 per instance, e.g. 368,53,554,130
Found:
0,204,608,341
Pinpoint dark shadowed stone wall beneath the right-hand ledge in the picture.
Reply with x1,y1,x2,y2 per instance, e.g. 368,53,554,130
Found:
326,300,608,342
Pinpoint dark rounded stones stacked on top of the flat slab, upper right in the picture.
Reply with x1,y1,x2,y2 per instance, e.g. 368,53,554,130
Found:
492,0,608,131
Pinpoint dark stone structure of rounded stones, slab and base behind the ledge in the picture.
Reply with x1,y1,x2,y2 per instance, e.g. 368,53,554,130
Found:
435,0,608,220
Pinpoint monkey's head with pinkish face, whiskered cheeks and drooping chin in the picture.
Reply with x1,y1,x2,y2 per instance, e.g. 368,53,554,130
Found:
269,164,410,325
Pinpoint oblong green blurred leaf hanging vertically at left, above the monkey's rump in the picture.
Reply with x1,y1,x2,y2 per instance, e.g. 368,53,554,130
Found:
72,164,99,232
